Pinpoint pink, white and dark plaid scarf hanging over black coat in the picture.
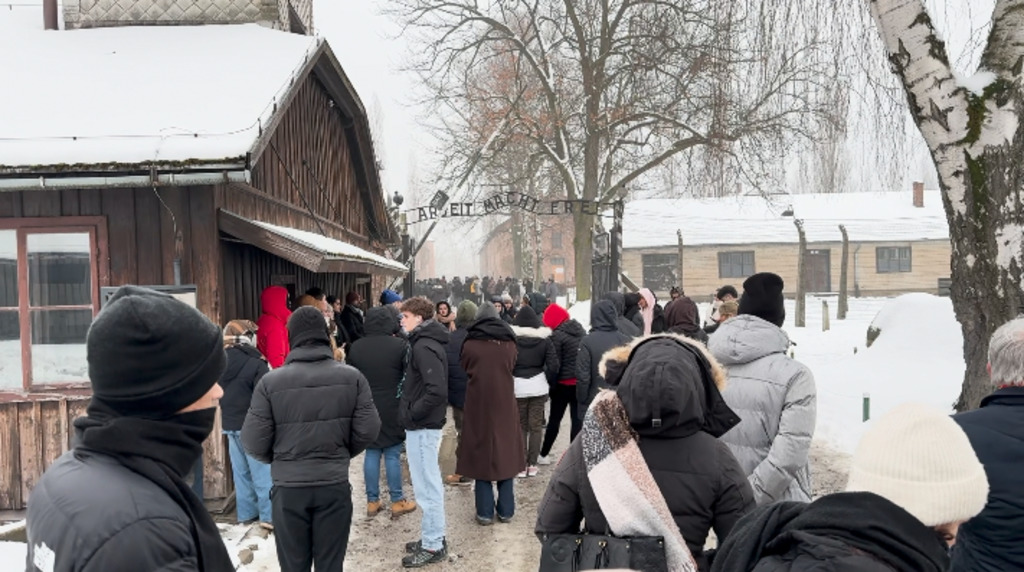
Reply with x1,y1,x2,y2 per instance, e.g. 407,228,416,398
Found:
580,391,697,572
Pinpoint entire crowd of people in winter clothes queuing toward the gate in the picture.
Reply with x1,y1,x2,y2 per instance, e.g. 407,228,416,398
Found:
19,273,1024,572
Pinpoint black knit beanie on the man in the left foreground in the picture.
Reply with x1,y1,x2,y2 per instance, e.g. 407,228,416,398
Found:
85,285,227,417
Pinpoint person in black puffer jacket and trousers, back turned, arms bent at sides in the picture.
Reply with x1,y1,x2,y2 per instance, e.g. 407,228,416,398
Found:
242,306,381,572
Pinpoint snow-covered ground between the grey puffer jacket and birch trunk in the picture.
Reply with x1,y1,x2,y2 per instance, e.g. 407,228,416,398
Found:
784,294,965,453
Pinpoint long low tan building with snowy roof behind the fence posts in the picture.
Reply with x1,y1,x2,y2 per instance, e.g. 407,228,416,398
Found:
623,183,951,298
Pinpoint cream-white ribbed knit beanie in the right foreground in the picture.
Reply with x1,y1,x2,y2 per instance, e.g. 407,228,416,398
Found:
846,403,988,526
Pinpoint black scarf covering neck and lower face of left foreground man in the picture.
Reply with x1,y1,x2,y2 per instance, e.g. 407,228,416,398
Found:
75,397,234,572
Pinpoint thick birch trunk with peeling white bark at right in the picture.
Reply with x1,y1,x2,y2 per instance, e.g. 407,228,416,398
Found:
867,0,1024,410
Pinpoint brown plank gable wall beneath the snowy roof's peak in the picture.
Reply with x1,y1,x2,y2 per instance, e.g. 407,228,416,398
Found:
249,76,370,237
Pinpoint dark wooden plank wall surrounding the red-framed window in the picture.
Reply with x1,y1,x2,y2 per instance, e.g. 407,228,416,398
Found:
0,186,231,509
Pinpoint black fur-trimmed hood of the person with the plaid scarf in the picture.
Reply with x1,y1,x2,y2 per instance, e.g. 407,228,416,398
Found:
602,335,739,439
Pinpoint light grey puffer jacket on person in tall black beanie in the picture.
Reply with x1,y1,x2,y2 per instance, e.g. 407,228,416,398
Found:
708,315,817,504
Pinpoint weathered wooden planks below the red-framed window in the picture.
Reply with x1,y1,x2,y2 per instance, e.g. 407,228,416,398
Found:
0,396,232,511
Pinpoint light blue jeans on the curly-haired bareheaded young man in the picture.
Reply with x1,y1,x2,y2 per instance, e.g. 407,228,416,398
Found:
406,429,444,551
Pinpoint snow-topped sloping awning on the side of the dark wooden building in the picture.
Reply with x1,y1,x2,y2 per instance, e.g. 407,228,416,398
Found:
217,210,409,276
